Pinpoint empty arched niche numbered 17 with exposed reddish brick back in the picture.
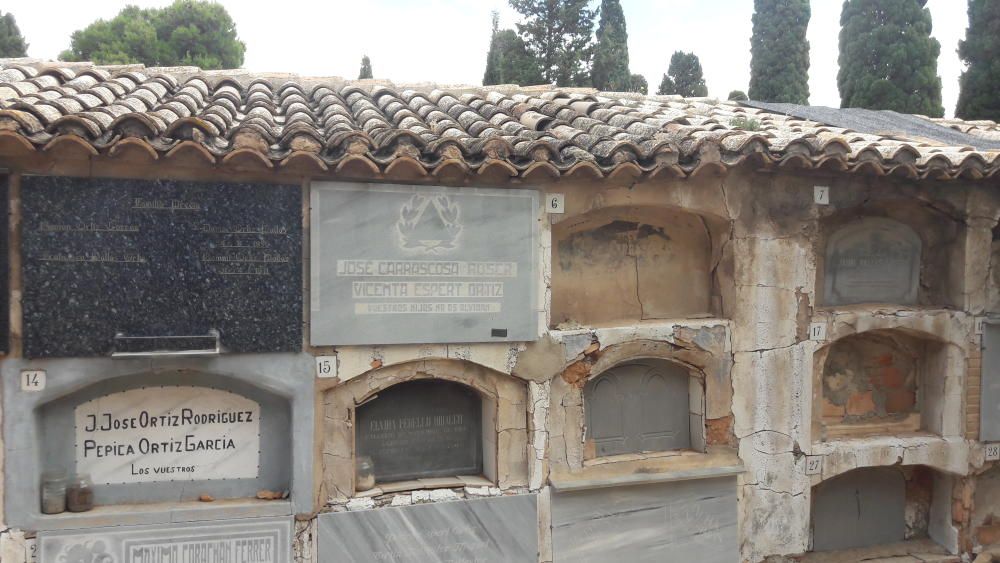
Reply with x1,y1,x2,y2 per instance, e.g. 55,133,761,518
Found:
816,330,947,440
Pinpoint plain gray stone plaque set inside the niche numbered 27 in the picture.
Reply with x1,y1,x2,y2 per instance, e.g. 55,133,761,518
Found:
812,468,906,551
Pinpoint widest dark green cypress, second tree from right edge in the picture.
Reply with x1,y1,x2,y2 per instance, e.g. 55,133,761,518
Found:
837,0,944,117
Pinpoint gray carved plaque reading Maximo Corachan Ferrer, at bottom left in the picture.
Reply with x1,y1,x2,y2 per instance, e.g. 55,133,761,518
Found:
38,518,292,563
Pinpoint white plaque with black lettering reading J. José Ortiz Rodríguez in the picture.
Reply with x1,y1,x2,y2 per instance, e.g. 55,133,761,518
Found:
74,386,260,485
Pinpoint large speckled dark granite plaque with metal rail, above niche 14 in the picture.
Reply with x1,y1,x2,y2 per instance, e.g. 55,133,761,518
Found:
21,177,302,358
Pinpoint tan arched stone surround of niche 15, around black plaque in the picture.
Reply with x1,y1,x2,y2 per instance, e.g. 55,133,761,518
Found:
321,360,528,498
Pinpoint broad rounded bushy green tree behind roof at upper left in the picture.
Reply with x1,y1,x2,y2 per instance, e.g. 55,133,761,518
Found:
59,0,246,69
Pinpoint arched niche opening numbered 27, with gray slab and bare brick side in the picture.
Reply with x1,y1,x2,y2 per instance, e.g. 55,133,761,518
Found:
810,466,936,551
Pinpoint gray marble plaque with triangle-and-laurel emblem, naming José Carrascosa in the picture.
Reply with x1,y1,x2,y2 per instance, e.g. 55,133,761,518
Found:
310,182,539,346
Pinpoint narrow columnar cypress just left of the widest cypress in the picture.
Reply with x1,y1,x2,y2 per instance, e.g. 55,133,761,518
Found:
750,0,810,105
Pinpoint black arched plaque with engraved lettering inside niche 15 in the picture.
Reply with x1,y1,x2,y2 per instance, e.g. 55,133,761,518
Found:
357,381,483,482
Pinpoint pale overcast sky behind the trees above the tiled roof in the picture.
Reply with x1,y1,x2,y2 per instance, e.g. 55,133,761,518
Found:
12,0,968,116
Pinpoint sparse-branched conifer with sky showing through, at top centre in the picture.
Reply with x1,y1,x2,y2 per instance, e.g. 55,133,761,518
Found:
509,0,594,86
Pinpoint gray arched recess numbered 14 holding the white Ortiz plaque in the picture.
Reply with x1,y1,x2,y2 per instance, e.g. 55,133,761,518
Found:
36,370,293,505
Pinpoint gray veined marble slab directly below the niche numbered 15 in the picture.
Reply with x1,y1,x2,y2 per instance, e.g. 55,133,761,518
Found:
317,494,538,563
